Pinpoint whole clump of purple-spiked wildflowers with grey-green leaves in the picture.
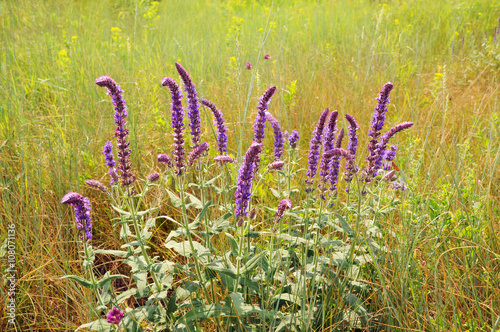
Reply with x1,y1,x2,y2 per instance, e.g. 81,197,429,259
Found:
61,68,413,331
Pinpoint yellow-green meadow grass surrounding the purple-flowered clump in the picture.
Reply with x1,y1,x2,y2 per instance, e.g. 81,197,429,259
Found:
0,0,500,331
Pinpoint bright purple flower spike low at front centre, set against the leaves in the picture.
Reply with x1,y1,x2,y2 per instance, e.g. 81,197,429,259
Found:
234,142,262,226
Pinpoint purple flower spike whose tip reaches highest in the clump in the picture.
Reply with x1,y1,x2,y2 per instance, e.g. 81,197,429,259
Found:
175,63,201,148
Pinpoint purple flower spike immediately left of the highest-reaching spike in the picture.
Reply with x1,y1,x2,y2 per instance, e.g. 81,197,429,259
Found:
161,77,186,175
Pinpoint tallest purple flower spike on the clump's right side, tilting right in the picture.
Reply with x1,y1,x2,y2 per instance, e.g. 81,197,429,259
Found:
363,82,394,182
